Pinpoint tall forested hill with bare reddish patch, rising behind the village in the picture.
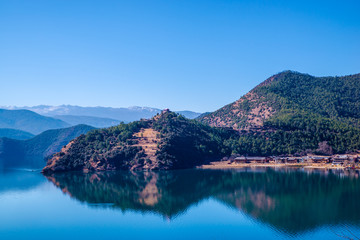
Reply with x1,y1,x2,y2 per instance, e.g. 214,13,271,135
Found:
199,71,360,155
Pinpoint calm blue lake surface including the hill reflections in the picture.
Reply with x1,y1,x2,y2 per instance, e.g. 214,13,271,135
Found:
0,168,360,240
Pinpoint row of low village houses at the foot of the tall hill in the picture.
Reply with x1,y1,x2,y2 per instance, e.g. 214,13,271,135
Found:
223,154,360,168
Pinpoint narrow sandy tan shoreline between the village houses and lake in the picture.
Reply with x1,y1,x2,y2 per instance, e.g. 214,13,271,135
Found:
198,160,359,170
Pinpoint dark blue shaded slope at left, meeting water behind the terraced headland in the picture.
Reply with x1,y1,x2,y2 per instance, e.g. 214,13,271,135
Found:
0,125,94,168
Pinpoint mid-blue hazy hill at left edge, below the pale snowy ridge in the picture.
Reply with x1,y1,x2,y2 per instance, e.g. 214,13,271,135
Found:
0,109,70,134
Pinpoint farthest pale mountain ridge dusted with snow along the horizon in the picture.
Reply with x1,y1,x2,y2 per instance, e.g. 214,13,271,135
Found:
3,105,201,122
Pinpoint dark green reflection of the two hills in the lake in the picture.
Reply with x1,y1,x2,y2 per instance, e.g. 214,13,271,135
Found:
47,168,360,234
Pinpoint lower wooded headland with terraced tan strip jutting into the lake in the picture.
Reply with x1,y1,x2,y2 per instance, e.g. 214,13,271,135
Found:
44,111,232,172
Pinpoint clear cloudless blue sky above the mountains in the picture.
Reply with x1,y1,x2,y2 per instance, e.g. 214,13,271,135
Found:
0,0,360,112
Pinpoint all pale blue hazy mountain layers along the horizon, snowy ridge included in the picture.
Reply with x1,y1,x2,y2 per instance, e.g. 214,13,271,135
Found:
0,105,200,140
